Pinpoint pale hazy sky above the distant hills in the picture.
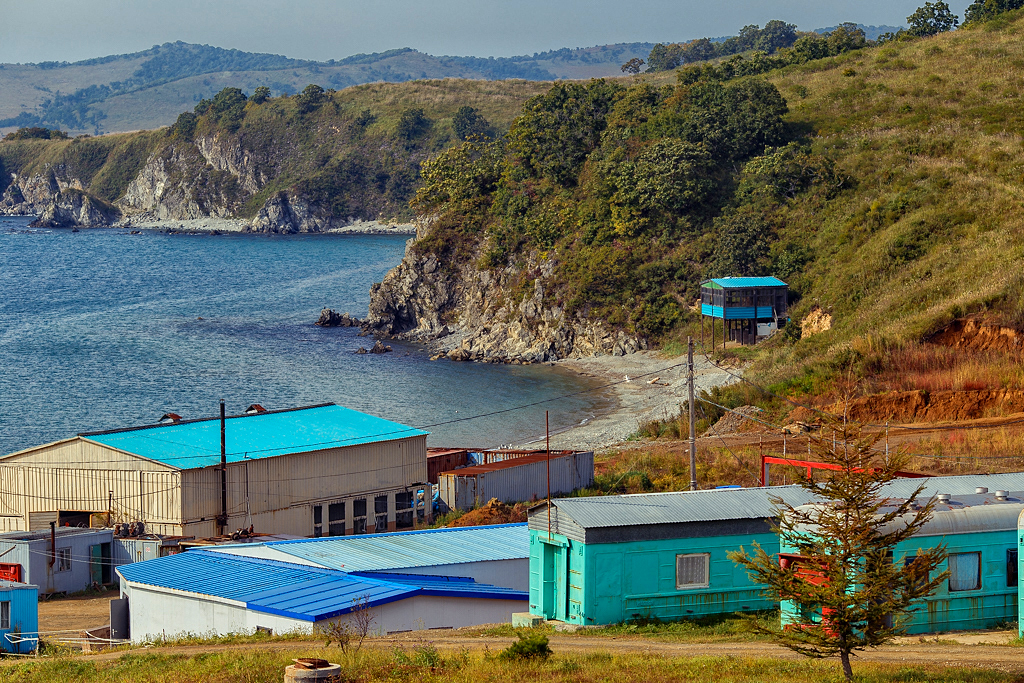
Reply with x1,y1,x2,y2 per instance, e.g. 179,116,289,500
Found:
0,0,969,62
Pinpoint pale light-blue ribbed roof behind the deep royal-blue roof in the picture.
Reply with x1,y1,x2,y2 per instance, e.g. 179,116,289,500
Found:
260,522,529,571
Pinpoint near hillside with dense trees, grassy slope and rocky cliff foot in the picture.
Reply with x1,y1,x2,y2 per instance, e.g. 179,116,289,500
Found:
362,5,1024,388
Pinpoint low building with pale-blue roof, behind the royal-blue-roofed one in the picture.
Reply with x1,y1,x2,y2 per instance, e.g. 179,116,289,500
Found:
209,522,529,592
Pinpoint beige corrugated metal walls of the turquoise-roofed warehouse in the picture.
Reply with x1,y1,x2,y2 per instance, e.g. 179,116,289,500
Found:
0,436,427,536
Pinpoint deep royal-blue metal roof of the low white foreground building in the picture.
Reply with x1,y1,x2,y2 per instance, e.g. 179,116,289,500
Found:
117,550,528,622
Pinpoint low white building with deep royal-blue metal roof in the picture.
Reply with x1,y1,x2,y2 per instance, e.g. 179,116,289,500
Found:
116,550,528,642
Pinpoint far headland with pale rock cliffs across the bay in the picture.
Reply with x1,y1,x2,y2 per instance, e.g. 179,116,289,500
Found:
0,80,548,232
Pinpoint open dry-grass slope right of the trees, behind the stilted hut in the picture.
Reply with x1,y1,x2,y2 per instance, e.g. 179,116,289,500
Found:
749,12,1024,388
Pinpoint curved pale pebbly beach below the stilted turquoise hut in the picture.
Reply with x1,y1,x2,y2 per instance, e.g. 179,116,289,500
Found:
519,351,736,451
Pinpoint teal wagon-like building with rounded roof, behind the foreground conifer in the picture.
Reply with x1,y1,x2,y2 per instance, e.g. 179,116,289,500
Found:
781,490,1024,635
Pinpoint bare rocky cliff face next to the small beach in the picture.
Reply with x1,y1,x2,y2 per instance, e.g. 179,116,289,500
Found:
364,225,647,362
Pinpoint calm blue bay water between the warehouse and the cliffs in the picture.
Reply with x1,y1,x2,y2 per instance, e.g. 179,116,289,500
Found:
0,217,604,454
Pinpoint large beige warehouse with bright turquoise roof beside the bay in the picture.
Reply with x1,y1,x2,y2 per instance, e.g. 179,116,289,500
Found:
0,403,431,538
